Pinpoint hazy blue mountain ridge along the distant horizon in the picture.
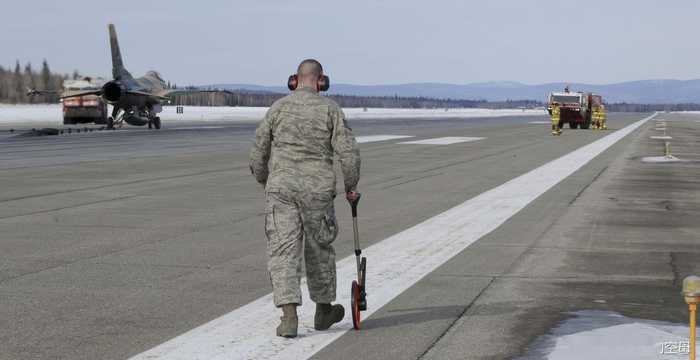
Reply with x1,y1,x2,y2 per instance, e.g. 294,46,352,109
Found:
206,79,700,104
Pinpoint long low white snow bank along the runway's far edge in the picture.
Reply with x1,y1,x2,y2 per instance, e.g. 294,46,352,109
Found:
0,104,543,125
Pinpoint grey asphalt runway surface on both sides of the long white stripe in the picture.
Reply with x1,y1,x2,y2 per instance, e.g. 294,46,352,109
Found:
0,114,700,359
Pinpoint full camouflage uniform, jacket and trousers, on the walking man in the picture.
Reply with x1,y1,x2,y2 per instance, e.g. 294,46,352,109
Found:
250,88,360,307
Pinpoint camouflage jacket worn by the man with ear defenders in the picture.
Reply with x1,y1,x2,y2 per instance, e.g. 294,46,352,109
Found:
250,88,360,193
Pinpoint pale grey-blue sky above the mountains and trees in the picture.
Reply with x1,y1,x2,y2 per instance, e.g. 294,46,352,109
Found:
0,0,700,85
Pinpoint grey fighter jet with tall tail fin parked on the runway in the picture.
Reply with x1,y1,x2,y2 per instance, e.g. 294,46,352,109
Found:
61,24,228,129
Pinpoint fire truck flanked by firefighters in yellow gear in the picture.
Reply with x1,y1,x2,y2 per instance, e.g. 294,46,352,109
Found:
547,91,603,129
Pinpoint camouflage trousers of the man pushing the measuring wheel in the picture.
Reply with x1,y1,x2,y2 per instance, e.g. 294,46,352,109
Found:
265,192,338,307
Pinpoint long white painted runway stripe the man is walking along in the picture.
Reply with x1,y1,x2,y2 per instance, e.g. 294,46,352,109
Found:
132,114,656,360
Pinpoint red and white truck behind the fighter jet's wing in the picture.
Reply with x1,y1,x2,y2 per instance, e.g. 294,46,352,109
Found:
62,77,107,125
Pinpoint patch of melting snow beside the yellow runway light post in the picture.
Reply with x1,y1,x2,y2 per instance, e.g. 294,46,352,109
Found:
519,310,690,360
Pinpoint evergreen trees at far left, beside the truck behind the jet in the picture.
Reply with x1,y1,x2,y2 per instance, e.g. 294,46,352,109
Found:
0,60,65,104
